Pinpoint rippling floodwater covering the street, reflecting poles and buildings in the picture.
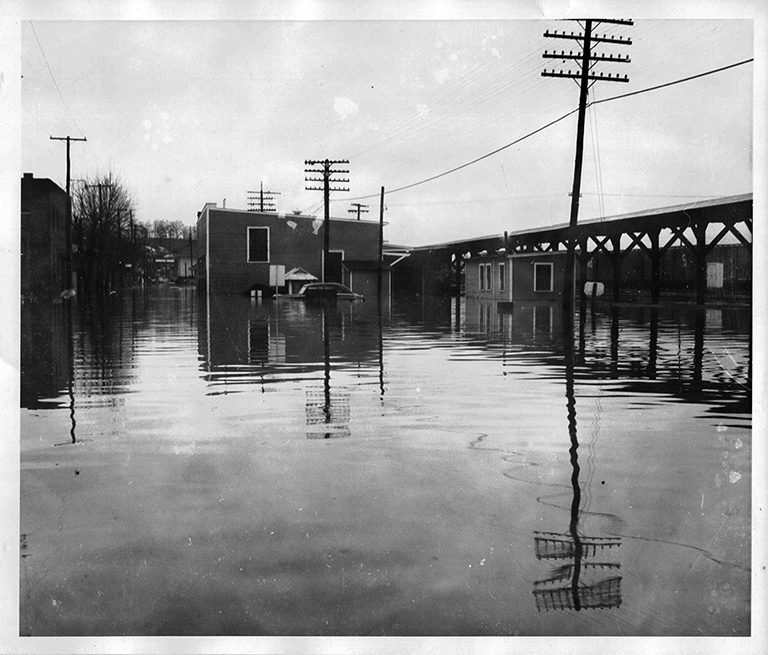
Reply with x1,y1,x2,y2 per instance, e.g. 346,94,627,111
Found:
19,287,752,636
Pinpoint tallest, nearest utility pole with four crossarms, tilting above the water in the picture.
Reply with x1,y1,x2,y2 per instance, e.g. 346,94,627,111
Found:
541,18,634,318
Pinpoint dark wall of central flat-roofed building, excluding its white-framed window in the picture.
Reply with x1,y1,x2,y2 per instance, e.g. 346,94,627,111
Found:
198,206,378,293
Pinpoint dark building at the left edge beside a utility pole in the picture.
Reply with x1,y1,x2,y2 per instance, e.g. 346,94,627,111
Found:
21,173,68,299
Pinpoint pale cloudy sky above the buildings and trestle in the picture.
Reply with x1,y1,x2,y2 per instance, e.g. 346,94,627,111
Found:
10,3,755,245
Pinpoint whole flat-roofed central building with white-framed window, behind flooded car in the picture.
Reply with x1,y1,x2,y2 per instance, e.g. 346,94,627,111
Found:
195,203,390,298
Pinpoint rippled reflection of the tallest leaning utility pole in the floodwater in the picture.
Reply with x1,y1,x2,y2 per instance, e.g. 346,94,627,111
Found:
533,316,621,611
